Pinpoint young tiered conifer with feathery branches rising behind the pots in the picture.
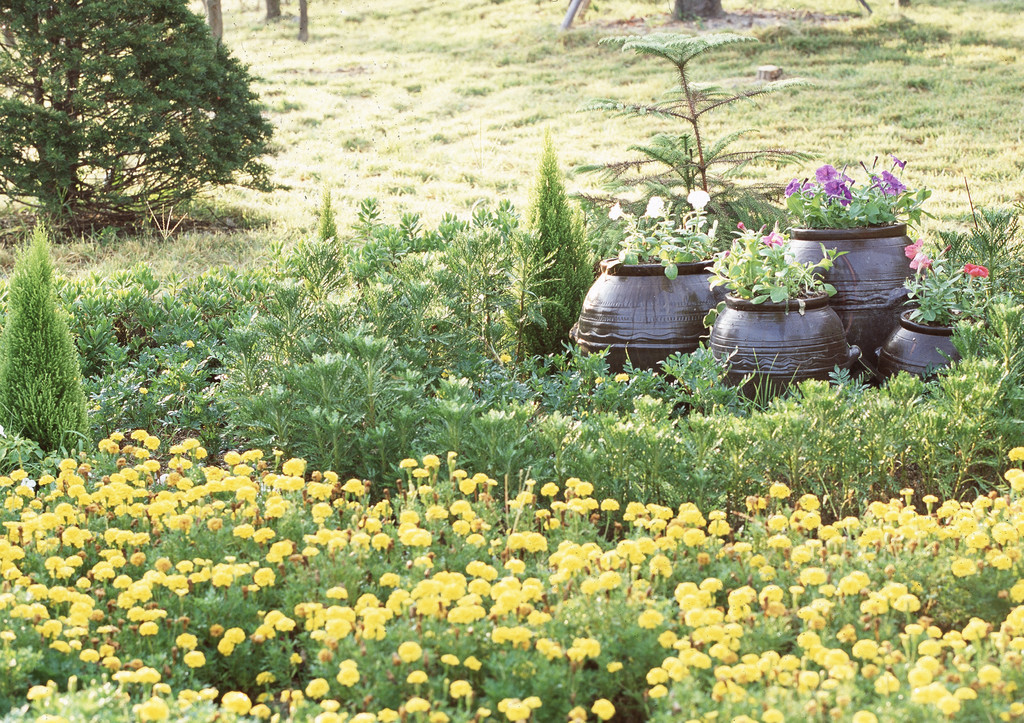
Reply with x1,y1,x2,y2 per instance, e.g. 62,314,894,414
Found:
581,33,809,225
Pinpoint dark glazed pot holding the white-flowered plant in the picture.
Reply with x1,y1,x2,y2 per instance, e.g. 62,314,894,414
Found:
569,259,718,373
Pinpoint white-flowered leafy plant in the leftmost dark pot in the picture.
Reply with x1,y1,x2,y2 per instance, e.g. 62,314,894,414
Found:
608,190,718,279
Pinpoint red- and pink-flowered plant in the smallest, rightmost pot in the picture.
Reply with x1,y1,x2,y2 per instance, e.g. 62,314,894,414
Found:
905,239,988,327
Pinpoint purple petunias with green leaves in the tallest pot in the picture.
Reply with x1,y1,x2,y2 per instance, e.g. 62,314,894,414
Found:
785,156,932,228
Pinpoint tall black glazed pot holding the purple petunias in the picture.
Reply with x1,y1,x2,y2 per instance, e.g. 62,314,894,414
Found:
790,223,912,367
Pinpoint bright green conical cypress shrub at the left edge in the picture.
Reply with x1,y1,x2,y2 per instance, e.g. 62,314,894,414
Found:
0,225,89,451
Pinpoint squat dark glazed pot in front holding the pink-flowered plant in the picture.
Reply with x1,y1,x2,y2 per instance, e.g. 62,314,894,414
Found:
708,294,860,396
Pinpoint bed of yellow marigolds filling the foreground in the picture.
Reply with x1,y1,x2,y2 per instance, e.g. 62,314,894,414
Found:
6,431,1024,723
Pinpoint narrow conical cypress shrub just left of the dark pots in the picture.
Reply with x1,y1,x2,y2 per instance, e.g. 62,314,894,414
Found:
523,135,594,354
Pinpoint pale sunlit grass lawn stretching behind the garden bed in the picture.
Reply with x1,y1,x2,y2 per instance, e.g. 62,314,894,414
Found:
6,0,1024,272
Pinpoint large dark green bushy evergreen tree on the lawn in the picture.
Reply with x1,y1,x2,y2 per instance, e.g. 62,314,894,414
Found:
0,0,271,227
